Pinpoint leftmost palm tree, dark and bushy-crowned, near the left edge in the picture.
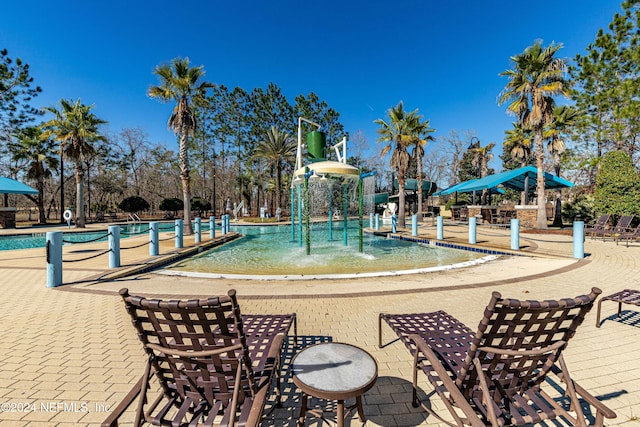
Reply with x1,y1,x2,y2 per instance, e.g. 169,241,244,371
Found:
11,126,58,224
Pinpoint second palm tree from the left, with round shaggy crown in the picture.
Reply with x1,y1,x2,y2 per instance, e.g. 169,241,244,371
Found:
42,99,107,228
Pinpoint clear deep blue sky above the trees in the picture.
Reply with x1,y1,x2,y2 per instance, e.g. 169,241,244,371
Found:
0,0,620,166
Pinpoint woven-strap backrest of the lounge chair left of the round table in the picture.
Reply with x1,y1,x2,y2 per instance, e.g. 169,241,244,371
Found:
120,289,256,406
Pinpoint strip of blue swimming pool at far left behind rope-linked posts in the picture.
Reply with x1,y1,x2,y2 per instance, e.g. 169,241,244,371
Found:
0,224,155,251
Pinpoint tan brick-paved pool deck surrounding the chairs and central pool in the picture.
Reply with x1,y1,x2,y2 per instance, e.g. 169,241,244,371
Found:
0,224,640,426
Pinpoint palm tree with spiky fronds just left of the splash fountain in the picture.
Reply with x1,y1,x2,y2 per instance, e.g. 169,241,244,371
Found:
253,126,296,214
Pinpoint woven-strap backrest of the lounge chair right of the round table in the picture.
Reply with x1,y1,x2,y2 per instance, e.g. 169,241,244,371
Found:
456,288,601,404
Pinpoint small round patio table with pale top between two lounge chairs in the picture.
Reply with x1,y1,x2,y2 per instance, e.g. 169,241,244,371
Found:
292,342,378,427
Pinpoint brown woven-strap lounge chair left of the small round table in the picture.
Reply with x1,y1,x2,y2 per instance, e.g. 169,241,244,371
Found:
102,289,296,426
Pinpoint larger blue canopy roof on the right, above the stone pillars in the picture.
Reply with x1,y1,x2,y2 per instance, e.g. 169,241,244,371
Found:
456,166,573,192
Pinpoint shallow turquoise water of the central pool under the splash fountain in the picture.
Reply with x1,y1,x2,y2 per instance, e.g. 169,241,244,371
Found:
164,223,484,278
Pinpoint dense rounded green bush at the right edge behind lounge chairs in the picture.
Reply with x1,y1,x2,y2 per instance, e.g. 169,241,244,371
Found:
593,151,640,217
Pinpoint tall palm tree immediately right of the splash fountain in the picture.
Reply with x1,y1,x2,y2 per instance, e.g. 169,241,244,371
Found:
374,101,417,227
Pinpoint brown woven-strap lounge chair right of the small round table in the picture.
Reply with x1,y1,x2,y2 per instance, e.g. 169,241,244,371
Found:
378,288,616,427
